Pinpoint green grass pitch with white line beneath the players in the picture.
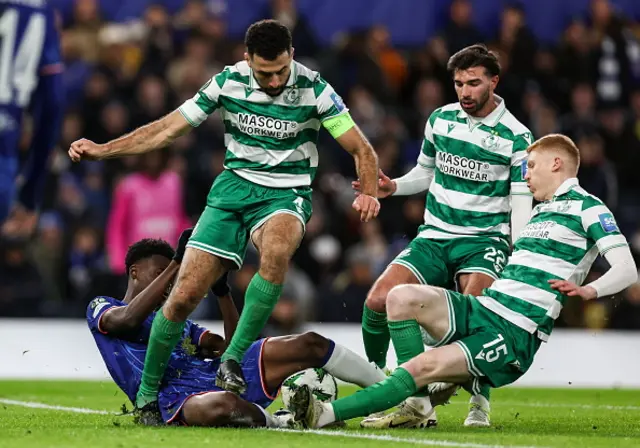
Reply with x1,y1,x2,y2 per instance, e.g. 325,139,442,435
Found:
0,381,640,448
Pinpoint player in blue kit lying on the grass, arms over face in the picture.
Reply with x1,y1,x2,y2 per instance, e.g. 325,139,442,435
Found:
87,231,386,426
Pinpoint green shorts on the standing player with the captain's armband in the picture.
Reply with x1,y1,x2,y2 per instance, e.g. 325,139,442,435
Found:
187,170,311,268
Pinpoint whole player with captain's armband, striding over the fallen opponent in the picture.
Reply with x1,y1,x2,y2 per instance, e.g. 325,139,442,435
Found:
69,20,380,420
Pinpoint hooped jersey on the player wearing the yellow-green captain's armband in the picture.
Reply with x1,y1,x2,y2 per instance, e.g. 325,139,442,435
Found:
179,61,348,188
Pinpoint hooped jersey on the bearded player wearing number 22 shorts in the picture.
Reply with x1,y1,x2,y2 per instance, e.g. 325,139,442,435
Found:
418,96,532,239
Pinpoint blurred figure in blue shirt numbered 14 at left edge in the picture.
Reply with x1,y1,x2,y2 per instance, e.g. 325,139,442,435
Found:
0,0,65,235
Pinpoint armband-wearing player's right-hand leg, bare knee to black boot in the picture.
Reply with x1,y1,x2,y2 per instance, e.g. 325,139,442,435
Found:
216,213,304,393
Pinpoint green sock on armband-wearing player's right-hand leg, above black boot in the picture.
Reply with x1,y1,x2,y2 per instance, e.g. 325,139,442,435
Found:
221,274,282,362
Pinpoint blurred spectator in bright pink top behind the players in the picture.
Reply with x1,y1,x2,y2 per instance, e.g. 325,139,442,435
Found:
106,151,190,274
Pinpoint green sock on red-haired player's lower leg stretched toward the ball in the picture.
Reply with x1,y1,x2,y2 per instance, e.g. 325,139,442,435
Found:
331,368,416,421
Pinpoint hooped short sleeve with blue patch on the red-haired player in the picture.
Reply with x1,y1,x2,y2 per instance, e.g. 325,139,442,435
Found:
581,198,628,256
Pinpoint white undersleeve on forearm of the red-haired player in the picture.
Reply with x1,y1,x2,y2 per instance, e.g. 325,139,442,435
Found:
586,246,638,297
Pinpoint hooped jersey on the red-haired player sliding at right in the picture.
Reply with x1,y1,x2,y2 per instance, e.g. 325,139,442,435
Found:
477,178,627,341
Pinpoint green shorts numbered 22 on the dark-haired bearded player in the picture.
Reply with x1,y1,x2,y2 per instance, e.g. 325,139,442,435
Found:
391,236,510,288
